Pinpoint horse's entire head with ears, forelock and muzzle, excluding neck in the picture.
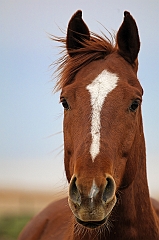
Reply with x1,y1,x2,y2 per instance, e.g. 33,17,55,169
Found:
58,11,144,228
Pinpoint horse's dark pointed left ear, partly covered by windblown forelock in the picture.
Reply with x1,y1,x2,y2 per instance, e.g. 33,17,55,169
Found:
66,10,90,57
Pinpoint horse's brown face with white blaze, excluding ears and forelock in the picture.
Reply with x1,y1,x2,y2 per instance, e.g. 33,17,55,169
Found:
61,10,142,228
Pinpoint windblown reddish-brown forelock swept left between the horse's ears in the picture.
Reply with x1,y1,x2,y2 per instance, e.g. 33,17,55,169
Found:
51,33,115,91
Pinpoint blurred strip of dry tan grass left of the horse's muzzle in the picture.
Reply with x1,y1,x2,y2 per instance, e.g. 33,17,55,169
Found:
0,189,66,217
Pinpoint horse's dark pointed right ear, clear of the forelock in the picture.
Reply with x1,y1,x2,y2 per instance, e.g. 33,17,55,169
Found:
117,11,140,64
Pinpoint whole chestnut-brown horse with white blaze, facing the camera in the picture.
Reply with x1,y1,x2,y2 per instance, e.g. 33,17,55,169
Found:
19,11,159,240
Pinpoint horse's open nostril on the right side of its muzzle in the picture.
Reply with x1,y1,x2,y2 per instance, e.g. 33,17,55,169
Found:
103,177,115,202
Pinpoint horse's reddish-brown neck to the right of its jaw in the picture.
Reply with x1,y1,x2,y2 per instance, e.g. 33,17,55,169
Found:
111,129,159,240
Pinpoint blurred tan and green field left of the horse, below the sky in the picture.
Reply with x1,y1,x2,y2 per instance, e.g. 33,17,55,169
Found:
0,189,66,240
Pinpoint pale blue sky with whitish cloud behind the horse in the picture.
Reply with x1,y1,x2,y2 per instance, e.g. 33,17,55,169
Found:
0,0,159,195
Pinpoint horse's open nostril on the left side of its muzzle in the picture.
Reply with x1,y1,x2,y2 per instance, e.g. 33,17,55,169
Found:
69,177,81,205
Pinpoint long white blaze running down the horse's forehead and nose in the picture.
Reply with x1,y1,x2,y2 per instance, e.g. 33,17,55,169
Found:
86,70,118,162
